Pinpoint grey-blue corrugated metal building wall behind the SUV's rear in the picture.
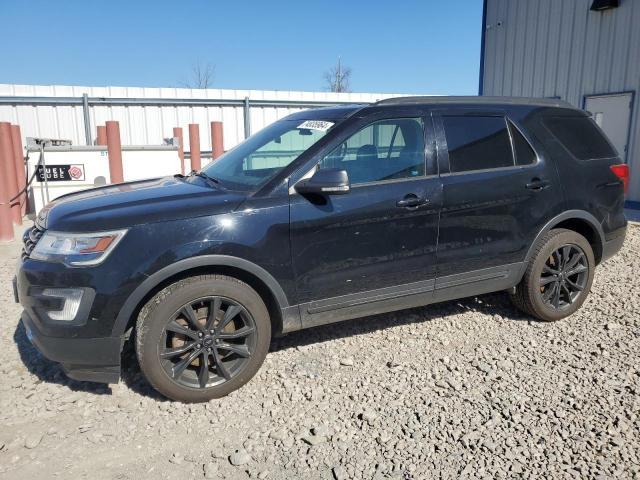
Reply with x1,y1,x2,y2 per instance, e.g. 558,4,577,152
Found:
482,0,640,201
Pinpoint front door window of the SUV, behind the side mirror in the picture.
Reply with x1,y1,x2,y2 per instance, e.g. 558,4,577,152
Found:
318,117,425,185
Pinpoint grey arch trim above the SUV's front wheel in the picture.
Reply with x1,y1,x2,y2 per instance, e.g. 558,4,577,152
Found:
112,255,289,336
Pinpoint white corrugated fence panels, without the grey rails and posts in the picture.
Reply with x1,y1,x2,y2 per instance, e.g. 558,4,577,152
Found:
0,84,408,151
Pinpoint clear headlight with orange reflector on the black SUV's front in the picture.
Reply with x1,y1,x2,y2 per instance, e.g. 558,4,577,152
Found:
30,230,127,267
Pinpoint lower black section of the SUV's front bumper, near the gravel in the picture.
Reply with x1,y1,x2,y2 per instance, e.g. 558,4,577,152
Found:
22,311,122,383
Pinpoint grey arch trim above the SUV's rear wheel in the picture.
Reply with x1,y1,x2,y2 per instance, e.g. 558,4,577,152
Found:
522,210,605,274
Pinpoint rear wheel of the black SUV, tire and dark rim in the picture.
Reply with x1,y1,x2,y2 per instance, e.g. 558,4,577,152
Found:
510,228,596,322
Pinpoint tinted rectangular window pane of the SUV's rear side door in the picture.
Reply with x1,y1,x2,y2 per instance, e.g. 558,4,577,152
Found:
442,116,514,173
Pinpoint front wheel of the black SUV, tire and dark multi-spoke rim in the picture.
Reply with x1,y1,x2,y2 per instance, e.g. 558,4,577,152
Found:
135,275,271,403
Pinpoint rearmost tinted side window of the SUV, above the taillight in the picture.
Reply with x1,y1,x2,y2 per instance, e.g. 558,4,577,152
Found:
544,117,617,160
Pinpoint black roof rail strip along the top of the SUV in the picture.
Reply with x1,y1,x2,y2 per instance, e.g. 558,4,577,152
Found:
374,95,575,108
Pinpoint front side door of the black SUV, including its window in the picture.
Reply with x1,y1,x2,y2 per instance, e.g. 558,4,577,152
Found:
290,112,442,326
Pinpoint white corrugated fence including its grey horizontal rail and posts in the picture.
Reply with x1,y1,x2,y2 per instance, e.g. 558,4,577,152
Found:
0,84,410,155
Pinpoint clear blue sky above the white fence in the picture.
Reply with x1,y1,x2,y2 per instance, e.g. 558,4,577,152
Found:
0,0,482,95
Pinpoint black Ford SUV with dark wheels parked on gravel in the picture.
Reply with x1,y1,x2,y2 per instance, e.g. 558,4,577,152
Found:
16,97,628,402
